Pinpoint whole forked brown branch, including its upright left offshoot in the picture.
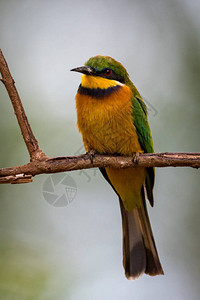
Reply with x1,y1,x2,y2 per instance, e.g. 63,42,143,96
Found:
0,50,200,183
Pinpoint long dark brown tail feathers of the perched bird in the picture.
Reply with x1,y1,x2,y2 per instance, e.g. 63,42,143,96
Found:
119,190,164,279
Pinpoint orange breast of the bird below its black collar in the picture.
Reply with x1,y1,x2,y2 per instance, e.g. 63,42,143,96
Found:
76,85,141,155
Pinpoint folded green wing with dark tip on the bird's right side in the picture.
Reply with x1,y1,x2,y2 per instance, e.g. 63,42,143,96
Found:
132,95,155,206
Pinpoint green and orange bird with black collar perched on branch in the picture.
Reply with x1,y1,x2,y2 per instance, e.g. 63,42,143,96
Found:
71,55,164,279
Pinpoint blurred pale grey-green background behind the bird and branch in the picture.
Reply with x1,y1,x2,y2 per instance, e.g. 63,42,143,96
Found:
0,0,200,300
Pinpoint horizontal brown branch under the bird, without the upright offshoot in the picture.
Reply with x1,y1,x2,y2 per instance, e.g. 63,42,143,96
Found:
0,153,200,183
